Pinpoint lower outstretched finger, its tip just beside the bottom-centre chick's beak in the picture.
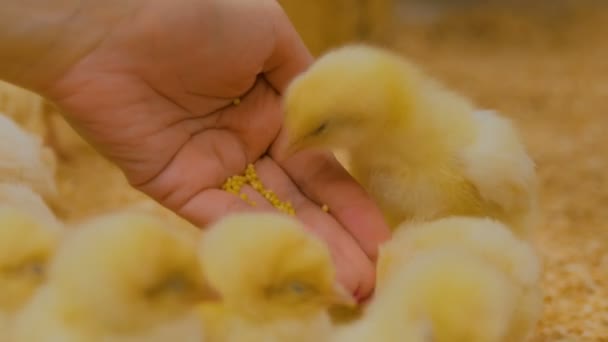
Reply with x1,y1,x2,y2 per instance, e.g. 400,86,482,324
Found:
247,158,375,299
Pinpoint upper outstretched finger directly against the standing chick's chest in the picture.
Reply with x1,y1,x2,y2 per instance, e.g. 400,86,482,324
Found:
274,151,391,260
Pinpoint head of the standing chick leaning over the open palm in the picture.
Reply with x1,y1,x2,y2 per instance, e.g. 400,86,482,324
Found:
283,44,416,152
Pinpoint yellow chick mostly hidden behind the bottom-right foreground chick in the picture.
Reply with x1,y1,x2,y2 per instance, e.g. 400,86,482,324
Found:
376,217,543,342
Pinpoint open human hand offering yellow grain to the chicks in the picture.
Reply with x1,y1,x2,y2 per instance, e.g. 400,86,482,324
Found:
0,0,389,298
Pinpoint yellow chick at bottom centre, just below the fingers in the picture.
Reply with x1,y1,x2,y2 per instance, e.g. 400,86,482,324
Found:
199,213,356,342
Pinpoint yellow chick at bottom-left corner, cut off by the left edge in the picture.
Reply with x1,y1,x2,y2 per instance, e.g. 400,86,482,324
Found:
0,204,61,342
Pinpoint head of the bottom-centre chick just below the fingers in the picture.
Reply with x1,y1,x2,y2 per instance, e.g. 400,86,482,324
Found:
200,213,354,318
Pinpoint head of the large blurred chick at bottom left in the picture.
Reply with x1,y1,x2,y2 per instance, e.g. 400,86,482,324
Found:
50,213,213,331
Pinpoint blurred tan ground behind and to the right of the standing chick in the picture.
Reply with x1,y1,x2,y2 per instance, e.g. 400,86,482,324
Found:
279,0,608,341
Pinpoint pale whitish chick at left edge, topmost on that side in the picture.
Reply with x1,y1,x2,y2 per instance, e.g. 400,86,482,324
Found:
0,114,57,198
